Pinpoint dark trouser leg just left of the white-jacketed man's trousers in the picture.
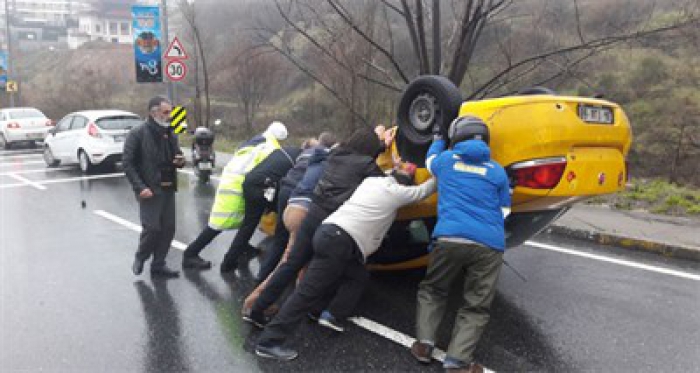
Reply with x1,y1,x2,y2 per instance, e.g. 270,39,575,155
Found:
252,203,329,312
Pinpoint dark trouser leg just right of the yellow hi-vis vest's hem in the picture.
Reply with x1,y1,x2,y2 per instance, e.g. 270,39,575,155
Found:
224,182,269,262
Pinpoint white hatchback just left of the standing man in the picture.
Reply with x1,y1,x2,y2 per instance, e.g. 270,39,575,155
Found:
44,110,143,173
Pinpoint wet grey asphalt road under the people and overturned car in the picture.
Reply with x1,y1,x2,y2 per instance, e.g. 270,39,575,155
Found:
0,150,700,372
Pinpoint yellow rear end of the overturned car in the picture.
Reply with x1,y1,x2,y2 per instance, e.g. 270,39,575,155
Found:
460,95,631,212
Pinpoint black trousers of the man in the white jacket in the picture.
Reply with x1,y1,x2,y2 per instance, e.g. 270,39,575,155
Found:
258,224,369,345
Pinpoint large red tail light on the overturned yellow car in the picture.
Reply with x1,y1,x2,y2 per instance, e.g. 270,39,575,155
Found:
510,157,566,189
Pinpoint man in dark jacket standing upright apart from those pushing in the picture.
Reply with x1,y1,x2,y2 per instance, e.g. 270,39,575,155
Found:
123,97,185,277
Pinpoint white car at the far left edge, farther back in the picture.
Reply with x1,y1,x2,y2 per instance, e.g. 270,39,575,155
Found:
0,107,53,149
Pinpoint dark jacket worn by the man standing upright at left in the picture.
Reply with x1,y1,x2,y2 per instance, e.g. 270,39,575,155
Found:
123,117,182,195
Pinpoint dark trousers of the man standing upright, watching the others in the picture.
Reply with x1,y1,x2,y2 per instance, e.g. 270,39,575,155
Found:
136,192,175,268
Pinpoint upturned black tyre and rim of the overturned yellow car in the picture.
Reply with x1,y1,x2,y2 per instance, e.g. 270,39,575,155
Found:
397,75,463,166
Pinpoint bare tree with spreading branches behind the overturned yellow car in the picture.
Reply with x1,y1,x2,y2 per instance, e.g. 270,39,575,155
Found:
261,0,698,104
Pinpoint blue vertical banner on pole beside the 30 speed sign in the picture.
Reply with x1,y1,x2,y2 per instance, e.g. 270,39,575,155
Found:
131,5,163,83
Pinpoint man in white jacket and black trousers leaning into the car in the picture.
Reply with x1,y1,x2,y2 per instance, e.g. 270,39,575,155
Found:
255,165,435,360
